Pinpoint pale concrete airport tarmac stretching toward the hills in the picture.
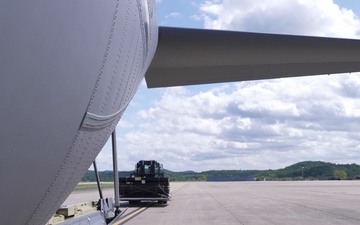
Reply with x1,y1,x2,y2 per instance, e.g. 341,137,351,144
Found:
63,181,360,225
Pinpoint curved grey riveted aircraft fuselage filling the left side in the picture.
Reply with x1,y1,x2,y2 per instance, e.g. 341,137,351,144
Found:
0,0,158,225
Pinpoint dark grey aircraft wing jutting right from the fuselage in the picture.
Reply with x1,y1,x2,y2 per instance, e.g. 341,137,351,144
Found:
145,27,360,88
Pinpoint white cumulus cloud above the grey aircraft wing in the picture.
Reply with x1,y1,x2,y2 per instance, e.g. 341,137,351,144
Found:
199,0,360,37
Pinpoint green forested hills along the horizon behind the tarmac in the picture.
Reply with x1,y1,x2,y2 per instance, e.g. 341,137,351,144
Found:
82,161,360,181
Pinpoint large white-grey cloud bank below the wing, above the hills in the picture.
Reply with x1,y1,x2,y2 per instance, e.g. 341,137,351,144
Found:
116,74,360,170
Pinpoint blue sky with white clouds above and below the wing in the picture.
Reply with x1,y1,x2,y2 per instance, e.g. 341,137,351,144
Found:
96,0,360,172
